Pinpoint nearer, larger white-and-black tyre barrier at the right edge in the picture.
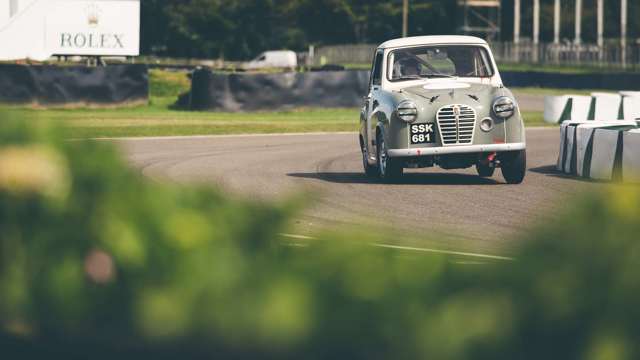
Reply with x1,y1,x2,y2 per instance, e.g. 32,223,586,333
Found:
556,121,640,182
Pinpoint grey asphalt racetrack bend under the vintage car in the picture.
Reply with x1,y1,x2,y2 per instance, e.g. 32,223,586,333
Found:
119,128,604,253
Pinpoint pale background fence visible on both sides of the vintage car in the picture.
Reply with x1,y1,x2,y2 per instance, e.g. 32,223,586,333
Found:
309,42,640,69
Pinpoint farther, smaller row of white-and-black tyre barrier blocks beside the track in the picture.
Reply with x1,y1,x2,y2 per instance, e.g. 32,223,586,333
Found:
544,91,640,124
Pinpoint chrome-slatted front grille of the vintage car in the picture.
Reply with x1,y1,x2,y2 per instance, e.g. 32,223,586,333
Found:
437,105,476,145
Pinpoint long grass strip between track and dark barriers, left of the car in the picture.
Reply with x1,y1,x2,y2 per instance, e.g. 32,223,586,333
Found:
10,104,359,138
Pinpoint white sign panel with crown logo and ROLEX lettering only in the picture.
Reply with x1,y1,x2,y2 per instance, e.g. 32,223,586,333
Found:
45,0,140,56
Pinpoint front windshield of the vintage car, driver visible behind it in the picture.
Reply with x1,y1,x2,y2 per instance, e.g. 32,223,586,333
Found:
388,45,493,81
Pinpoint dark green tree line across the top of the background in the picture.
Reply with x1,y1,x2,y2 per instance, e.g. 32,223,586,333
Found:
141,0,640,60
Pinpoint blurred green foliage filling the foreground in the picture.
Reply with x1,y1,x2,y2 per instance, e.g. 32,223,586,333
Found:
0,116,640,360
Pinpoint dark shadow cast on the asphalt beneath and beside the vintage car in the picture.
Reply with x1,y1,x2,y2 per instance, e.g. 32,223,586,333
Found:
287,172,502,185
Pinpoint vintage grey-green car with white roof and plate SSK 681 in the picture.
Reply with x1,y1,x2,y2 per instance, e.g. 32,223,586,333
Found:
360,36,526,184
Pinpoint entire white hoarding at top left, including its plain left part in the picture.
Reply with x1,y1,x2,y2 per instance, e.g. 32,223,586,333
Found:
0,0,140,60
